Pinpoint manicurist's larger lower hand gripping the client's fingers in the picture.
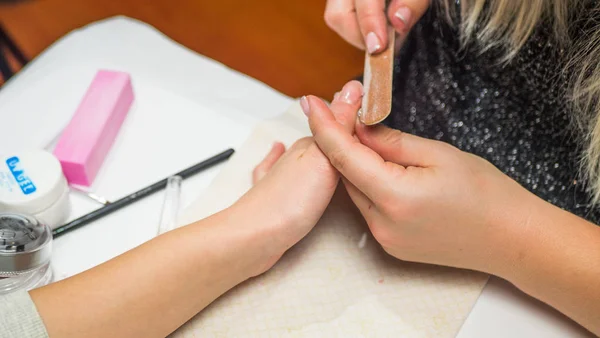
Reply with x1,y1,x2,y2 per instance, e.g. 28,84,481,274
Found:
307,82,540,274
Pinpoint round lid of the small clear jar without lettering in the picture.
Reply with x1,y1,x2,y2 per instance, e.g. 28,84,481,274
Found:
0,213,52,277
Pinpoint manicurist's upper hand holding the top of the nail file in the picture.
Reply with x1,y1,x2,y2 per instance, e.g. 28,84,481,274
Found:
325,0,429,54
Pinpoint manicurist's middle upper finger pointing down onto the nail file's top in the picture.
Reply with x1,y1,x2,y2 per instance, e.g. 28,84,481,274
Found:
356,0,388,54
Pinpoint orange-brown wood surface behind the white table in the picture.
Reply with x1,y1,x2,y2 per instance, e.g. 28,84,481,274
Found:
0,0,364,98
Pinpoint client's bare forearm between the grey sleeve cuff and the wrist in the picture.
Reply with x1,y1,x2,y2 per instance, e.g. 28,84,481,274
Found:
30,210,259,337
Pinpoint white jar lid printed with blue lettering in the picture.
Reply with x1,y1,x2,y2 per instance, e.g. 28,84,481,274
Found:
0,150,67,215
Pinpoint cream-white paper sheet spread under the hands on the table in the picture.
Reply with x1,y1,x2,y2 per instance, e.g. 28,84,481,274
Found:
173,103,487,337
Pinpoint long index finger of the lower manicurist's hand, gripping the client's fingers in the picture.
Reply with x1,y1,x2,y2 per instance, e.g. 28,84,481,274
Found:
303,96,397,200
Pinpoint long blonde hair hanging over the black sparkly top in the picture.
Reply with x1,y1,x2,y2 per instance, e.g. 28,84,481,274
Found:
438,0,600,205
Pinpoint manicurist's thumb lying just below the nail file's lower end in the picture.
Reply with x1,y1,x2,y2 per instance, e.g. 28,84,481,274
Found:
356,123,454,168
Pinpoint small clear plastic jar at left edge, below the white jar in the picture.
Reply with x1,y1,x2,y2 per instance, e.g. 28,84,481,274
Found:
0,213,52,295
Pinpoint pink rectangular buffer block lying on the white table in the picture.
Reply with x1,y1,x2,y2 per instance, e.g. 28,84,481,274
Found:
54,70,133,186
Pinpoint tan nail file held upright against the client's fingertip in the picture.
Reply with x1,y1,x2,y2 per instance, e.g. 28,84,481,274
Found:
359,27,396,125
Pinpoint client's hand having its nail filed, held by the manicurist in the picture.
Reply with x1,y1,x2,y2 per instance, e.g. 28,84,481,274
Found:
233,81,362,273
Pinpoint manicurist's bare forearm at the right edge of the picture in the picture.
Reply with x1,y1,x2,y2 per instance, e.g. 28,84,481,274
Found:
503,201,600,335
